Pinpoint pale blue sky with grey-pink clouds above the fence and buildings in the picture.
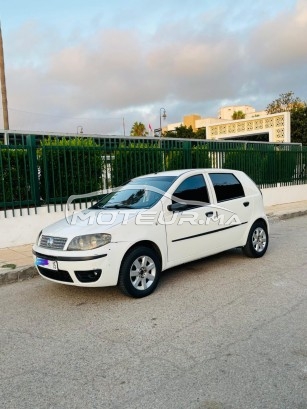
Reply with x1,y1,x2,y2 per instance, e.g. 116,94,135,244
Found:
0,0,307,135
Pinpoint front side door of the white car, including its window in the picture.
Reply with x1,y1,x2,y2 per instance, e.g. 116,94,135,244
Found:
164,173,218,266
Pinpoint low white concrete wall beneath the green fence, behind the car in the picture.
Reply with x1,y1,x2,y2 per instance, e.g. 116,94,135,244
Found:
0,185,307,248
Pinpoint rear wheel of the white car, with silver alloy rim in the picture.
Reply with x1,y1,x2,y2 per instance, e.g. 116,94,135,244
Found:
243,220,269,258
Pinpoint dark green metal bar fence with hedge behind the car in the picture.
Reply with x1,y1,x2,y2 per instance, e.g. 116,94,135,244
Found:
0,135,307,216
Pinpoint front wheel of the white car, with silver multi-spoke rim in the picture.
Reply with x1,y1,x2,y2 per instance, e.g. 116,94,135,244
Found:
118,246,161,298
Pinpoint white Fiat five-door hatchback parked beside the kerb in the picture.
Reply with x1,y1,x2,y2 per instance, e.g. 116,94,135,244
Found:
33,169,269,298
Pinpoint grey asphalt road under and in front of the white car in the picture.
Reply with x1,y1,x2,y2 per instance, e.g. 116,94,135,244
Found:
0,216,307,409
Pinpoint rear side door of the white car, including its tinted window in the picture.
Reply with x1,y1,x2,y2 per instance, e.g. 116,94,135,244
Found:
209,171,254,251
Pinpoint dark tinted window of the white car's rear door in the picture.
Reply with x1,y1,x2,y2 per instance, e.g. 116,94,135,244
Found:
209,173,245,202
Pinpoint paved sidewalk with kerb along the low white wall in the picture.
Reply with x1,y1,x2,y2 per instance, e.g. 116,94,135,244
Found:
0,201,307,286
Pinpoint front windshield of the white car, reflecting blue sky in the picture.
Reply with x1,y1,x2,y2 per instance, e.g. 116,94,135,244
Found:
91,176,177,209
